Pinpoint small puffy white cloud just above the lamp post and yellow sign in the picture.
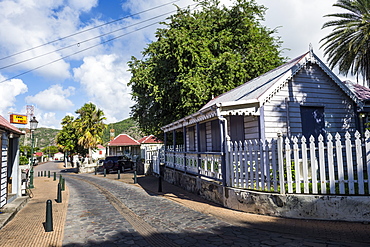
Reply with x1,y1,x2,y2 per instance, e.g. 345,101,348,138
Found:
26,85,75,111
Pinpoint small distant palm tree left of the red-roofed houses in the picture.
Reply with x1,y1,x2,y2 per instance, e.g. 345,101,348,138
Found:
74,103,106,163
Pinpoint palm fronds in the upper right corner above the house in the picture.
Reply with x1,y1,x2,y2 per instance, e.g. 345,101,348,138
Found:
320,0,370,86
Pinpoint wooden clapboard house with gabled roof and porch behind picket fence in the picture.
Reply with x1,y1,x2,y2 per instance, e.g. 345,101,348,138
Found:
162,50,370,183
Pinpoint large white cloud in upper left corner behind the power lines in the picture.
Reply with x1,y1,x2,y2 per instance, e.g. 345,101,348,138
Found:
0,0,99,80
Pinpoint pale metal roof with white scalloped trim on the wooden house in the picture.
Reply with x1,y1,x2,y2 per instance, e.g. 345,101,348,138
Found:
162,50,364,132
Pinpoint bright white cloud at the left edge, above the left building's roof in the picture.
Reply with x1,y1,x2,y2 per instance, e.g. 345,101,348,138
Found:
0,74,28,116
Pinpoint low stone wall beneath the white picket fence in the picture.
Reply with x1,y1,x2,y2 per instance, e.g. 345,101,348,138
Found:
164,168,370,222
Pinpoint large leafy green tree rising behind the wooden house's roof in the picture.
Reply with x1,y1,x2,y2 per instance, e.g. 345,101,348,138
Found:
129,0,284,136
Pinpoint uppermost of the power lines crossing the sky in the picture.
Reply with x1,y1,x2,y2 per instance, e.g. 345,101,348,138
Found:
0,0,180,61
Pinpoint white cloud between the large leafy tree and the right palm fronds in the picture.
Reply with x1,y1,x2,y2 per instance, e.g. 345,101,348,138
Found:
256,0,338,60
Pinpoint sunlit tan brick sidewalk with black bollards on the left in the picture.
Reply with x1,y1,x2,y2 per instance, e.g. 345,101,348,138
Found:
0,177,69,247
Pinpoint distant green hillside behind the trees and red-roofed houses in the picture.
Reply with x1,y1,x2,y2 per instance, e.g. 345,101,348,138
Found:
19,118,144,150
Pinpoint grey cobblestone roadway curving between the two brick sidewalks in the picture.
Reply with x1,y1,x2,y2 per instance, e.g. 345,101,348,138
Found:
35,168,356,247
